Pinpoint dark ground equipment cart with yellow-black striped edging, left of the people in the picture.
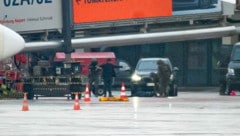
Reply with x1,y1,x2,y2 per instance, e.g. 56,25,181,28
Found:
23,60,84,99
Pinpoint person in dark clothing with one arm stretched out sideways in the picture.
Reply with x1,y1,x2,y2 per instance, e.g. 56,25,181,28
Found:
100,58,122,97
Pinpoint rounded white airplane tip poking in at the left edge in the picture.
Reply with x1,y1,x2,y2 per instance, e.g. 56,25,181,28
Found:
0,24,25,61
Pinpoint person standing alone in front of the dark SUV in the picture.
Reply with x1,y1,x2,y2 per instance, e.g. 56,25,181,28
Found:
157,60,171,97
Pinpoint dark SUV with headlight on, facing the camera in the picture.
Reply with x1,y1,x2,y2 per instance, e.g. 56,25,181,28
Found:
131,58,178,96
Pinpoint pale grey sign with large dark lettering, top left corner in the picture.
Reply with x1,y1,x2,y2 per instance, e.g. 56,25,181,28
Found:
0,0,63,33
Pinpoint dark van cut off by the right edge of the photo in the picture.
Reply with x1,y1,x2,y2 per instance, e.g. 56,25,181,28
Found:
225,43,240,95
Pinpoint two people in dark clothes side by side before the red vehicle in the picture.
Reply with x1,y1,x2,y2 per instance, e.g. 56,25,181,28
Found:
88,58,122,97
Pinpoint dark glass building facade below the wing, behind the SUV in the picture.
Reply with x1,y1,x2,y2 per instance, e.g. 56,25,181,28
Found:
109,38,232,86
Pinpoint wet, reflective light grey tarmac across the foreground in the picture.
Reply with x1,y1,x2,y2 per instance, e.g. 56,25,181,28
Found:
0,88,240,136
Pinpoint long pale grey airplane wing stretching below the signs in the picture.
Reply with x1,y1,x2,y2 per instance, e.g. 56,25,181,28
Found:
23,26,240,51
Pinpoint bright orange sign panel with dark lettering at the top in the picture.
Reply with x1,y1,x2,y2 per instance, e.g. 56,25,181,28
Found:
73,0,172,24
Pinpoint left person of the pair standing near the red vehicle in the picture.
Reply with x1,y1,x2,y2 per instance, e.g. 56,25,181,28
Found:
88,59,101,96
